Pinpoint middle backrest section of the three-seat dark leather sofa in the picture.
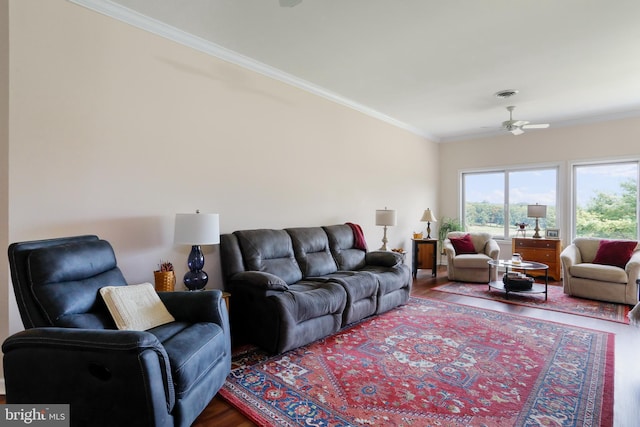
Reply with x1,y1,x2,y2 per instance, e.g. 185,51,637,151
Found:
285,227,338,277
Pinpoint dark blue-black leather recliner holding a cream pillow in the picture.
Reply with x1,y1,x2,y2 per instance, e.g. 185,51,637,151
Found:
2,236,231,426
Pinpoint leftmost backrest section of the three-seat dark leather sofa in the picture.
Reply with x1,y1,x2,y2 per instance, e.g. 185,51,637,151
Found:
233,229,302,285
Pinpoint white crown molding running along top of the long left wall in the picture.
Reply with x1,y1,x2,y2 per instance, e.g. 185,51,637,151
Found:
67,0,439,142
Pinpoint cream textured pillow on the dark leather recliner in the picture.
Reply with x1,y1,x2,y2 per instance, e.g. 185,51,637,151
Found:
100,283,176,331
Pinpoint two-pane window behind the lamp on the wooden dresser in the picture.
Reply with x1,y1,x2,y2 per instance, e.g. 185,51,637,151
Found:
462,167,558,238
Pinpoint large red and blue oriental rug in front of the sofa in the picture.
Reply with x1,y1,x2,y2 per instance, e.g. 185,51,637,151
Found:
220,298,614,427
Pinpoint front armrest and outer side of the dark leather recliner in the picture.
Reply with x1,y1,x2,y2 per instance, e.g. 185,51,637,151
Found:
2,328,175,425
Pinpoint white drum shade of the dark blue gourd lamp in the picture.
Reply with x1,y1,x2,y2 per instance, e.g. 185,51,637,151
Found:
173,211,220,245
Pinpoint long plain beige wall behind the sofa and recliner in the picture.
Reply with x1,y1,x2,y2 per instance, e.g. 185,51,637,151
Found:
0,0,439,388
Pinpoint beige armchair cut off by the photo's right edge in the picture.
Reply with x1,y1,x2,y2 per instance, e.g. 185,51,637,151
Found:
560,237,640,305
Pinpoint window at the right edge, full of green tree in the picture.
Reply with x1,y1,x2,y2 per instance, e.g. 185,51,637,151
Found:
572,161,639,240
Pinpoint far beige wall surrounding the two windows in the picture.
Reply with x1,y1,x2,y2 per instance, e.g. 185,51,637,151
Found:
438,117,640,256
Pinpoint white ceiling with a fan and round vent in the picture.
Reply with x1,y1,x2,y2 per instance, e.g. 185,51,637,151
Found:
79,0,640,142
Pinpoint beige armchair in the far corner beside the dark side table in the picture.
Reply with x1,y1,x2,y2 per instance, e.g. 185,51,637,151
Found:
443,231,500,283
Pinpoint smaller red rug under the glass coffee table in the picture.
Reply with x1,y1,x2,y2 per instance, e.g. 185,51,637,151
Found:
433,282,629,324
